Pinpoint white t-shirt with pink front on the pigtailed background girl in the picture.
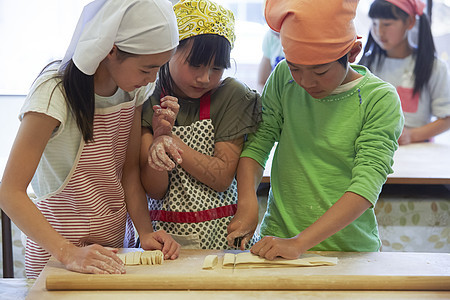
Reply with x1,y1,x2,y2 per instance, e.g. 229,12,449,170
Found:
372,55,450,127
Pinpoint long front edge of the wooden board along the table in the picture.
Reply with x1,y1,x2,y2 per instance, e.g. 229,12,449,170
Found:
46,274,450,291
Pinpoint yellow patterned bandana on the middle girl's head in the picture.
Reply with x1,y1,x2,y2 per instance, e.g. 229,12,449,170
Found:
173,0,236,49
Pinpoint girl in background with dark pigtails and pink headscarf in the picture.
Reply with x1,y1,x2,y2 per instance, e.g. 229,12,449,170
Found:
360,0,450,145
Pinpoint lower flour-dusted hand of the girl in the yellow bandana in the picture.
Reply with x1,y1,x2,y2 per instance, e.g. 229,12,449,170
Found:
148,135,183,171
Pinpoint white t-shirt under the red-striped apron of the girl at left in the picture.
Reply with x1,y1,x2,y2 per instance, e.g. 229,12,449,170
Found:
19,72,154,198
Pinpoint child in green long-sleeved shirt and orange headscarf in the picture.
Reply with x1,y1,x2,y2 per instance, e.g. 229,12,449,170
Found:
229,0,403,259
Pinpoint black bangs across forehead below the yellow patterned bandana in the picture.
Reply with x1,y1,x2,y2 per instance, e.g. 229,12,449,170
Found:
178,34,231,69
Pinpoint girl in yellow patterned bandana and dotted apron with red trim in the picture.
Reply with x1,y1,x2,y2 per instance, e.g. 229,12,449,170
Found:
141,0,261,249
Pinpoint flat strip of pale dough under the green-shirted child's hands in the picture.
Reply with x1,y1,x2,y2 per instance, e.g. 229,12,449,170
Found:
222,252,338,269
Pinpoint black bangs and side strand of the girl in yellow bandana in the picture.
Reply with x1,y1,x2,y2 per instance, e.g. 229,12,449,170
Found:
158,34,231,95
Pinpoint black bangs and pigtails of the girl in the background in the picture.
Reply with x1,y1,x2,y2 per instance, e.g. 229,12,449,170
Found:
359,0,436,94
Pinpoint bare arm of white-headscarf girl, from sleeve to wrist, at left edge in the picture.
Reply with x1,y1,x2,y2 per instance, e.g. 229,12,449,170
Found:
0,112,75,260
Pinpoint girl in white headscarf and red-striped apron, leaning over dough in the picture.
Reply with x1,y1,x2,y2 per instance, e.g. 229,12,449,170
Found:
0,0,179,278
